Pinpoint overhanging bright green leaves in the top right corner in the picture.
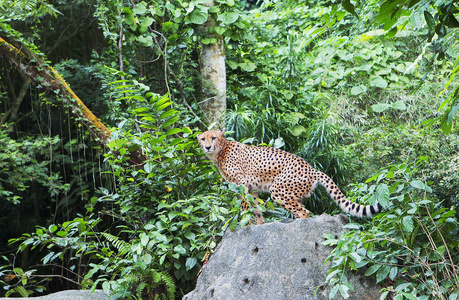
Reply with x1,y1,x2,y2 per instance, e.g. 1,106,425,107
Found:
343,0,459,134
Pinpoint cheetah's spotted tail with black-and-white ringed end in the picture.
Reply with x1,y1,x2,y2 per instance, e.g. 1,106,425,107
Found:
320,174,382,218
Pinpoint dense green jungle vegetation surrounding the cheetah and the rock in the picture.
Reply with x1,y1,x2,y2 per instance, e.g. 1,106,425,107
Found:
0,0,459,300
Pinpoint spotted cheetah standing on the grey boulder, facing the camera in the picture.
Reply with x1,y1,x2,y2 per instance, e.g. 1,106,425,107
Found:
197,130,382,224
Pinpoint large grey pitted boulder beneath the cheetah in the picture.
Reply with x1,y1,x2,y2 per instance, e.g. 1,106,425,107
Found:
183,215,381,300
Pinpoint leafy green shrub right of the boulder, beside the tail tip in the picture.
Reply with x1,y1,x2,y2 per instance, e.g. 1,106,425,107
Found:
324,158,459,299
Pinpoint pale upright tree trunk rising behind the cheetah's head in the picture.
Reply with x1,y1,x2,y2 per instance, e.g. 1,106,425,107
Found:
199,0,226,129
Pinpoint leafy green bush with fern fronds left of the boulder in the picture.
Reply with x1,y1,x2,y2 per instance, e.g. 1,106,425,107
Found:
4,73,258,299
